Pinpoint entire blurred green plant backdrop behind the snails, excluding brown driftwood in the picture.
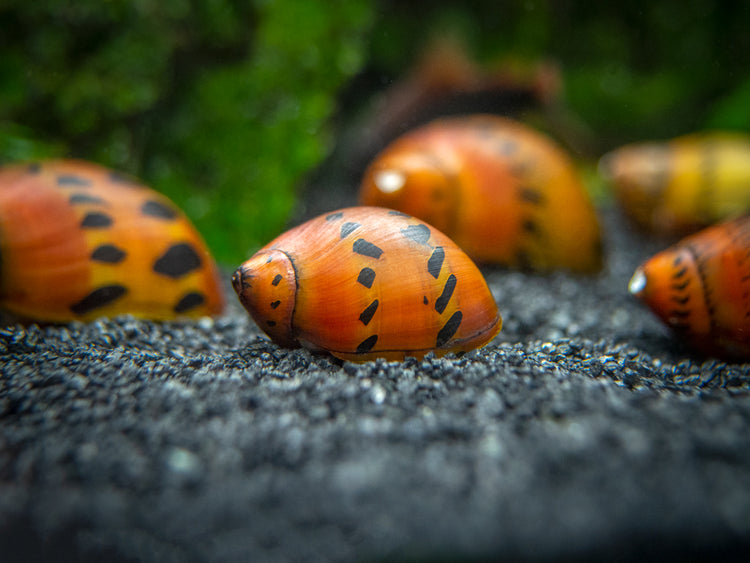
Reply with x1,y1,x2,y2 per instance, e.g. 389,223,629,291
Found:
0,0,750,266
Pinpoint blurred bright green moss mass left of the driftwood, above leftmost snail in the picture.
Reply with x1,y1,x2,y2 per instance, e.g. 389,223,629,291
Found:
0,0,372,265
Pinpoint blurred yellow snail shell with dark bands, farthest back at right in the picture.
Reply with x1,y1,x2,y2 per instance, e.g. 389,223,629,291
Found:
599,132,750,235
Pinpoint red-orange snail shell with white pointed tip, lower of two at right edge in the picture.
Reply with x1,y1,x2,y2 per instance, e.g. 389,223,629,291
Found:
629,216,750,360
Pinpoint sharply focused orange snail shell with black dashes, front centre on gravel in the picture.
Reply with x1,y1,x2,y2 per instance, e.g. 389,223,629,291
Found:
232,207,502,361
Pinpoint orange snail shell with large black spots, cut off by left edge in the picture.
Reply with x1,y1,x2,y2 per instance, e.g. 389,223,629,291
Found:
0,160,224,322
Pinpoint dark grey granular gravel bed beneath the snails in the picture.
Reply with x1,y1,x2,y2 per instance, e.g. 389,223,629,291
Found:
0,209,750,561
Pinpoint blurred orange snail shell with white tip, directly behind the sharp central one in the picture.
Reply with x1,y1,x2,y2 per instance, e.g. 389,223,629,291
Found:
360,115,602,272
